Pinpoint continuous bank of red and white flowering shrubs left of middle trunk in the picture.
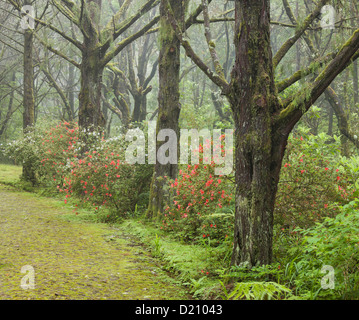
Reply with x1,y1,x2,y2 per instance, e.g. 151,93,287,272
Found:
6,122,152,217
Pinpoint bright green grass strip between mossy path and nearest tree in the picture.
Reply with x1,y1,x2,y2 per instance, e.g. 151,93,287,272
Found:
117,219,231,299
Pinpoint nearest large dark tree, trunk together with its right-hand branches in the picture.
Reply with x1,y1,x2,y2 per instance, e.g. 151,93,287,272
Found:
229,0,359,266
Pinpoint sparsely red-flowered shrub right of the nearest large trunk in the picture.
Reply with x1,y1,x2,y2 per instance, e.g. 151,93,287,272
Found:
275,130,355,230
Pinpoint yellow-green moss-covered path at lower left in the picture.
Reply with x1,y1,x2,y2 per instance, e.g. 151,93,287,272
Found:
0,182,191,300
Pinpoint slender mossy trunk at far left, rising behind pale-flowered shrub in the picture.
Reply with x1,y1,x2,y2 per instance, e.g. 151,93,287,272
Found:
22,11,36,185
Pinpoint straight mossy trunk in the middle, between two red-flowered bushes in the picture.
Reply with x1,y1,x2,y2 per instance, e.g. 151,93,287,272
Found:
147,0,187,218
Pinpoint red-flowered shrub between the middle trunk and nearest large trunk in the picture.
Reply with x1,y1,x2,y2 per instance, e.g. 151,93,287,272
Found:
162,136,234,243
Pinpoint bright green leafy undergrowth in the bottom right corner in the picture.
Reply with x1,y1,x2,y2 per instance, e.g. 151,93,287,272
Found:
275,200,359,300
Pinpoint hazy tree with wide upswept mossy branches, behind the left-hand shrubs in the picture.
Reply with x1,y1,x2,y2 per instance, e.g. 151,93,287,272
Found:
8,0,159,128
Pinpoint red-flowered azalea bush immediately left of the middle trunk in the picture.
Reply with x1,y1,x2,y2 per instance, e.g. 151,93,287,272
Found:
58,138,152,218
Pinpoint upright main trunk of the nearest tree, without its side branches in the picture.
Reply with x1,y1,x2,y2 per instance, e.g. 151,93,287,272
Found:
228,0,287,267
